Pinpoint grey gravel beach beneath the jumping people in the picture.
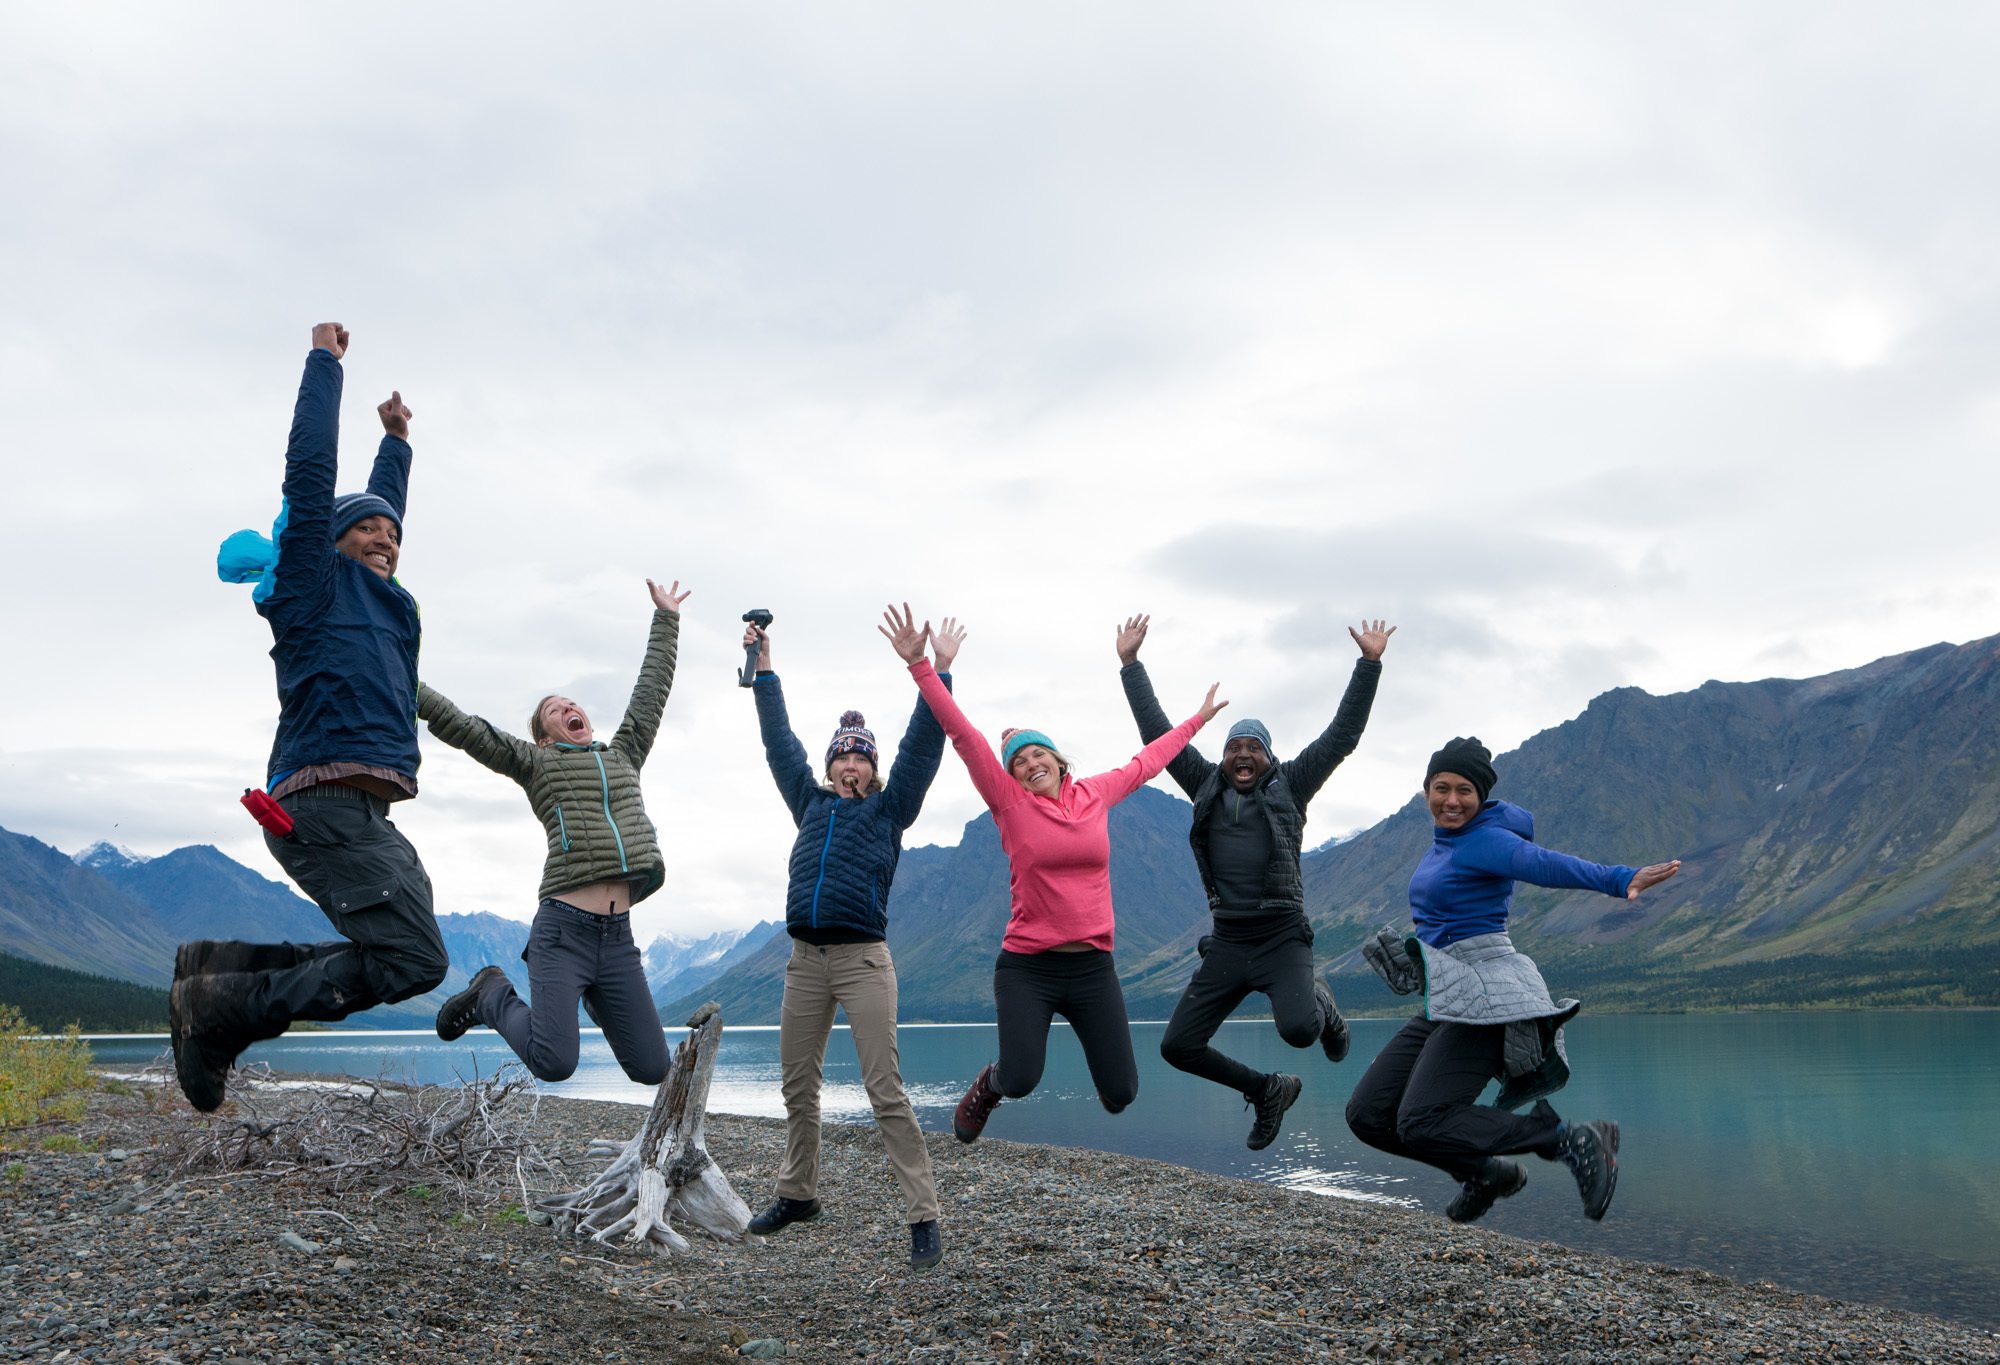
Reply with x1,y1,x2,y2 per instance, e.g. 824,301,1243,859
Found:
0,1083,2000,1363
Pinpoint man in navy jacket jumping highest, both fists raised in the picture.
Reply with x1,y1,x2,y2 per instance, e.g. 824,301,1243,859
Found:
168,322,448,1111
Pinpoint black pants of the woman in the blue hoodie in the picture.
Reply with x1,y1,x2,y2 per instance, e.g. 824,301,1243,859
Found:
1348,1015,1558,1181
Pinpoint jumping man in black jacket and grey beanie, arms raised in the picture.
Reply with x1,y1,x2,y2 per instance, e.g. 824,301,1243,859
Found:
1118,616,1396,1151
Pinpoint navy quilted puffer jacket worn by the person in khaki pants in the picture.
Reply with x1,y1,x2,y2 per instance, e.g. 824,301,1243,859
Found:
752,672,952,939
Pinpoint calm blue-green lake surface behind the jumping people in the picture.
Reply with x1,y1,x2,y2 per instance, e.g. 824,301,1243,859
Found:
92,1013,2000,1327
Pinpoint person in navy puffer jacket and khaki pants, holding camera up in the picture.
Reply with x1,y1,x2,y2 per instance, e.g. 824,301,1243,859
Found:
744,604,966,1269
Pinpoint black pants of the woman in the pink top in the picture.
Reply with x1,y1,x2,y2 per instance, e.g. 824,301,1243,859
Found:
994,949,1138,1113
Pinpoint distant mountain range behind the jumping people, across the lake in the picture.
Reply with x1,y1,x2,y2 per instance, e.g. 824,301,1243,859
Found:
0,636,2000,1027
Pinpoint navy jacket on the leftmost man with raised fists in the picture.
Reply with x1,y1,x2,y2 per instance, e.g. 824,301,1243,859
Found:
256,348,422,785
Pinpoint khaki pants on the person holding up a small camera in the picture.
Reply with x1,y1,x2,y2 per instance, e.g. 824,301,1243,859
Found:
778,939,938,1223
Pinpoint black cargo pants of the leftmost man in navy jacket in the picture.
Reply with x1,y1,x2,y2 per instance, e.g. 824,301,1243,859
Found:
232,783,450,1037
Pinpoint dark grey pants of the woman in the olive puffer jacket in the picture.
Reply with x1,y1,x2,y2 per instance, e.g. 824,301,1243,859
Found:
474,897,666,1085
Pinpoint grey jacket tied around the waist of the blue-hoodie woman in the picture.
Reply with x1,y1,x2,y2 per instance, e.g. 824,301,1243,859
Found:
1362,929,1582,1109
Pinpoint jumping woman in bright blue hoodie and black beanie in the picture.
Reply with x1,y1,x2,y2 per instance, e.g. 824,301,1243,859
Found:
1348,739,1680,1223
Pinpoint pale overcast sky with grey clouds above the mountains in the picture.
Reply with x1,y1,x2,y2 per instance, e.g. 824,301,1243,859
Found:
0,0,2000,939
